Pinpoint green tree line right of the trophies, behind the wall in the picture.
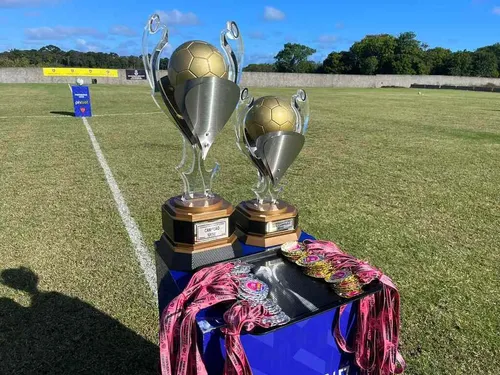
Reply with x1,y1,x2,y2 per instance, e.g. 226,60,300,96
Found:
243,32,500,77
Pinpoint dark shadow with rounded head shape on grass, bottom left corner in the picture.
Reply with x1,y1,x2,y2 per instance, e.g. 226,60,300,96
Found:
0,268,158,374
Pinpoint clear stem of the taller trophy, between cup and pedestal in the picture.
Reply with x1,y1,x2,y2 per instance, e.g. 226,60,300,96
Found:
176,136,219,200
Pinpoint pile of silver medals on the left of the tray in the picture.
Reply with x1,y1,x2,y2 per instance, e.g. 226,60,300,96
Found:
231,263,290,327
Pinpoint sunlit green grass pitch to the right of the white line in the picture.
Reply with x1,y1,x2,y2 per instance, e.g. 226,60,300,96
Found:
92,86,500,374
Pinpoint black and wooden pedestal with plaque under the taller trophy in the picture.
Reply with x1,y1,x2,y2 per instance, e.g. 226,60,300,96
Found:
155,196,239,271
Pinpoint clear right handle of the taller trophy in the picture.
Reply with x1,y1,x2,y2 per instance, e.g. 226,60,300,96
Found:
220,21,245,85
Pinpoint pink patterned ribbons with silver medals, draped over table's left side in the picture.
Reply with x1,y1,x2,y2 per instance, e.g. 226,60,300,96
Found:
160,262,290,375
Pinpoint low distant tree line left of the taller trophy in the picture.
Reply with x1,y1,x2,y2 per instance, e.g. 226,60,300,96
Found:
0,45,168,69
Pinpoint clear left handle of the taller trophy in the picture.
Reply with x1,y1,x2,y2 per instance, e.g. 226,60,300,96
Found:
142,14,168,95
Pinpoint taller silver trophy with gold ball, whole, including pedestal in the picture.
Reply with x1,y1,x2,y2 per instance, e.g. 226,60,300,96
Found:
143,14,243,270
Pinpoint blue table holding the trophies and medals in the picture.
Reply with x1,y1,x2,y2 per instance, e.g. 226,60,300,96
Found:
156,233,364,375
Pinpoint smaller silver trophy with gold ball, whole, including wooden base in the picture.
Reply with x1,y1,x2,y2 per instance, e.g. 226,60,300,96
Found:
235,88,309,247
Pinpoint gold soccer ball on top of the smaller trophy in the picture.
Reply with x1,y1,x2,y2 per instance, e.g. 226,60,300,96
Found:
245,96,296,142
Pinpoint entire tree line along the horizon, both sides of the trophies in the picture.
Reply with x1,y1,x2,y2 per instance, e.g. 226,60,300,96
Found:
0,32,500,77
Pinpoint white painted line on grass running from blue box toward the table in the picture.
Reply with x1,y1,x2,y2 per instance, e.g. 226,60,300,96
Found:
68,84,158,301
